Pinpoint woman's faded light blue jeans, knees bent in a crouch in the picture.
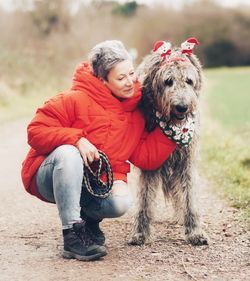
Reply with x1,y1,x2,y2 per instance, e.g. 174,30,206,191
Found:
36,145,133,229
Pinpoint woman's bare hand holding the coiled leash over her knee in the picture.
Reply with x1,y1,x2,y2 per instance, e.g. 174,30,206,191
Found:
76,138,100,166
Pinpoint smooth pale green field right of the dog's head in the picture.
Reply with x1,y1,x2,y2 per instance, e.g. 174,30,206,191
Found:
205,67,250,131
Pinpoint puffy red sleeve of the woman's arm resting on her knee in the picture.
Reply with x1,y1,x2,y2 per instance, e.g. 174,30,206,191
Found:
28,94,86,154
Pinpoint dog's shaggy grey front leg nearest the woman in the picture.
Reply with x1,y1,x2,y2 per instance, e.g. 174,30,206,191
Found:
128,171,159,245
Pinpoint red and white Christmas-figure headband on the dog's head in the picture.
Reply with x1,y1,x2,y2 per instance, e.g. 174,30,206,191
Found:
153,37,200,64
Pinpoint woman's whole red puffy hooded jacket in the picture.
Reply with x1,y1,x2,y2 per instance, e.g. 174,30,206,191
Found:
22,63,176,200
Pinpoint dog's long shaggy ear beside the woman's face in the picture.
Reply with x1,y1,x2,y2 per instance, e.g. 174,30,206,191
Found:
138,53,162,131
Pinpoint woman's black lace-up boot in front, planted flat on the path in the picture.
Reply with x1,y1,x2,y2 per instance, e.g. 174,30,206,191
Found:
63,221,107,261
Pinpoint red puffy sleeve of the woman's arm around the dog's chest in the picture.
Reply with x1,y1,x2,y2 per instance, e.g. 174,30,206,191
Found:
129,127,176,170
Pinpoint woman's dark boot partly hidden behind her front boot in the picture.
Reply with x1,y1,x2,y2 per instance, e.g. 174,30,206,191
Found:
81,209,105,246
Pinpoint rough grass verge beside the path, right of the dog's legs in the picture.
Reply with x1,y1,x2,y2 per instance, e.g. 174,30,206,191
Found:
201,122,250,225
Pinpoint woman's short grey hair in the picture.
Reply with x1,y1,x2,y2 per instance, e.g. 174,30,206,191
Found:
88,40,132,80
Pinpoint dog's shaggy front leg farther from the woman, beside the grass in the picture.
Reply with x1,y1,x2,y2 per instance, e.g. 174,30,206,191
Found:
179,165,208,246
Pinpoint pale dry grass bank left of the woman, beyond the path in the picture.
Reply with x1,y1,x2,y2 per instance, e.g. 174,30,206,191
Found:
0,47,74,122
